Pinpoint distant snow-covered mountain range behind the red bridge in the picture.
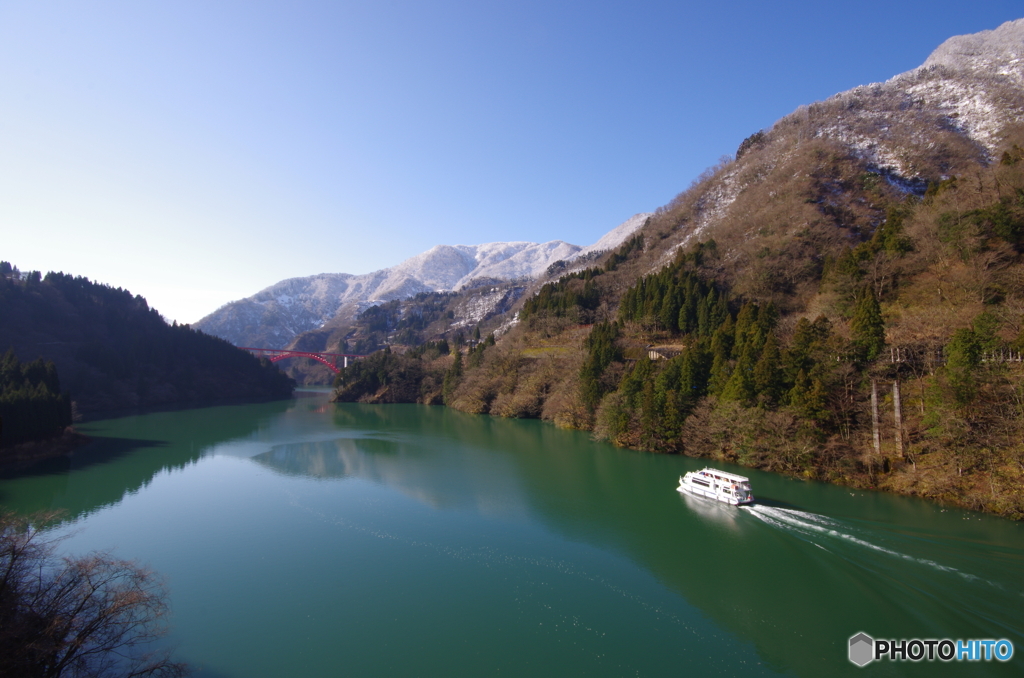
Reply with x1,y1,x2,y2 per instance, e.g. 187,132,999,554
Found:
195,219,647,348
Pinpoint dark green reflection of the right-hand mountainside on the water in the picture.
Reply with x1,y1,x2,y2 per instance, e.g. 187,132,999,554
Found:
247,406,1024,675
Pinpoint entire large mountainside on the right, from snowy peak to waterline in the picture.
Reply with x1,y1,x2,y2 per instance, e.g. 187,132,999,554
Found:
338,22,1024,518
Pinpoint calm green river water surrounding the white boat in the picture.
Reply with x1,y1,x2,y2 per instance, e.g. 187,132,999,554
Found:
0,393,1024,678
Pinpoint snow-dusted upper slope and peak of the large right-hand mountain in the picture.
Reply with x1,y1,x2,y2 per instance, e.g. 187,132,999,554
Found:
651,18,1024,266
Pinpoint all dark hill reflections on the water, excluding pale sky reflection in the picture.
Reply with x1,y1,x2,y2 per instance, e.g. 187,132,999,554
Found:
0,399,1024,676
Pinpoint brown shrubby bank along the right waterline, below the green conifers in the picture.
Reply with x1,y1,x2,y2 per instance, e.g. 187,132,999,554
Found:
334,346,1024,520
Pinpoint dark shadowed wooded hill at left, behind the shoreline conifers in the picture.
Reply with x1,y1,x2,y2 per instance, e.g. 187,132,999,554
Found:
0,262,294,413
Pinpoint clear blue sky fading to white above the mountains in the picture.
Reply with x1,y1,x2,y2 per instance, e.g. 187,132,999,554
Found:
0,0,1024,323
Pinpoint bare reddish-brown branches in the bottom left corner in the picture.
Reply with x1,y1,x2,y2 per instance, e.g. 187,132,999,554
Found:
0,512,187,678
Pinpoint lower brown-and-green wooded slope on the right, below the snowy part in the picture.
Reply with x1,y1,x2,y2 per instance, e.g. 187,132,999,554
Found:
338,139,1024,517
